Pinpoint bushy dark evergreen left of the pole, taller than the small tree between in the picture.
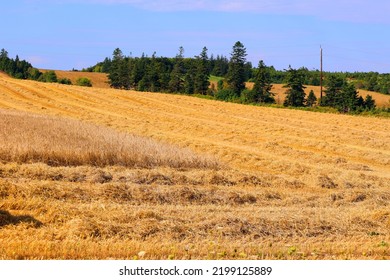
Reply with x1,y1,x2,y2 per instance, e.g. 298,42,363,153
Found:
283,66,306,107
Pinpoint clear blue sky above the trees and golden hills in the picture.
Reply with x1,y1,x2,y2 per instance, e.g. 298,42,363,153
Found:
0,0,390,73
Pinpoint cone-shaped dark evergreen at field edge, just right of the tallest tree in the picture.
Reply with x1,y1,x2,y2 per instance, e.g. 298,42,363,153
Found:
253,60,275,103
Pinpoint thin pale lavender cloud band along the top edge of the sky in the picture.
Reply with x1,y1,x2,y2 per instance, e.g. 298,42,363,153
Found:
25,0,390,24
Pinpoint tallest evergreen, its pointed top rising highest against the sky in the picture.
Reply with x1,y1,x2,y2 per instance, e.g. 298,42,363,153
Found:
227,41,247,97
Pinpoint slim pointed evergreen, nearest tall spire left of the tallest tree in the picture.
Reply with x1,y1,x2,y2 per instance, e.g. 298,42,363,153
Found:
194,47,210,94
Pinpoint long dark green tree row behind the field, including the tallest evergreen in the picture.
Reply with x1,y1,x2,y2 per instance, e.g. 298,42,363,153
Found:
90,41,376,112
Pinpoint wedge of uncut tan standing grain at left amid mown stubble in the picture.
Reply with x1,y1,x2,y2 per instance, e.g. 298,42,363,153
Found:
0,110,218,168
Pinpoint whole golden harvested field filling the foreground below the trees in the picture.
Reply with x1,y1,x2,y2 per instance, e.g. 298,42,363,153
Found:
0,72,390,259
